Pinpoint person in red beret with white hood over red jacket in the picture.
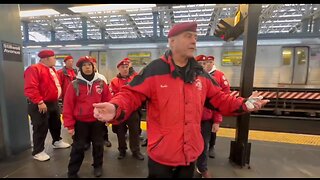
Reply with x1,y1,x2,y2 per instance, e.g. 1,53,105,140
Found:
63,56,111,178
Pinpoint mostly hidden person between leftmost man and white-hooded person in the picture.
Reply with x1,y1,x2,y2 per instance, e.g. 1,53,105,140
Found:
57,56,77,101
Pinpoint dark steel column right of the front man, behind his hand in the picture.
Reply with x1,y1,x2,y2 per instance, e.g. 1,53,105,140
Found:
229,4,262,167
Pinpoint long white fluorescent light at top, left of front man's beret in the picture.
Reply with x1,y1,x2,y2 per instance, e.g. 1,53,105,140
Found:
68,4,156,13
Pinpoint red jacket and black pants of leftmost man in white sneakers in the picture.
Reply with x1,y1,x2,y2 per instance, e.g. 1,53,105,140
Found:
24,62,62,155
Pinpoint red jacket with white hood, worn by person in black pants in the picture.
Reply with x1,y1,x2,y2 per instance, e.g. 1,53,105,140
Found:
62,74,111,129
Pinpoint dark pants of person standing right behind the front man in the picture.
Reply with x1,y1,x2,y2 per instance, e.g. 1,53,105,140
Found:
196,120,213,173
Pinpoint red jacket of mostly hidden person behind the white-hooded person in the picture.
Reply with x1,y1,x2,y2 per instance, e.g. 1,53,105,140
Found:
57,66,77,100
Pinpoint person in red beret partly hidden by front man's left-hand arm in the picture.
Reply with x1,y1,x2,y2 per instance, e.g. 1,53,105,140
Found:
110,58,144,160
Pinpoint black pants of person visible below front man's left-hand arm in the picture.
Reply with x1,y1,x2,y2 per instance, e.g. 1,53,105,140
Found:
112,111,140,153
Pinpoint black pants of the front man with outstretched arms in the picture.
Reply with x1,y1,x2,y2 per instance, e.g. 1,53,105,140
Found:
148,157,195,178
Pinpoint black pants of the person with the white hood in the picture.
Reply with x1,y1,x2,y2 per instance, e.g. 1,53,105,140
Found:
68,121,105,175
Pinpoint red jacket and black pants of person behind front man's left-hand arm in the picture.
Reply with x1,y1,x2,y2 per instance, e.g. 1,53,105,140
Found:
110,73,140,158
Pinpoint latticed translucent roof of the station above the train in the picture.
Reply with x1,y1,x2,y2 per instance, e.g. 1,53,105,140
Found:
20,4,320,42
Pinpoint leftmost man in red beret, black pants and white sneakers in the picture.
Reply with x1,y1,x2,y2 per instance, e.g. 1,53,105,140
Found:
24,50,70,161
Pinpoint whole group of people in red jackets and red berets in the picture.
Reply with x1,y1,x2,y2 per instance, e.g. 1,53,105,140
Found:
24,22,268,178
